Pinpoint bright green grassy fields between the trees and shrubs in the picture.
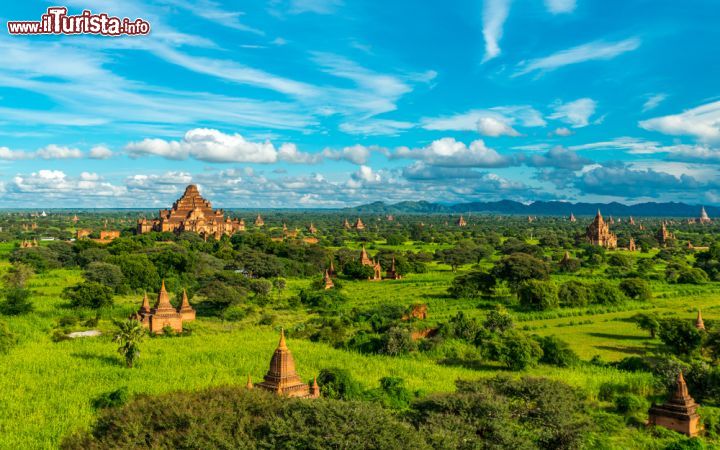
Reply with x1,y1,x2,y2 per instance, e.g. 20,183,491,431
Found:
0,245,720,448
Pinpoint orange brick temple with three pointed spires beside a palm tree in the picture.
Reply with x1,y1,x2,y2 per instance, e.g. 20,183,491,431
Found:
130,280,195,334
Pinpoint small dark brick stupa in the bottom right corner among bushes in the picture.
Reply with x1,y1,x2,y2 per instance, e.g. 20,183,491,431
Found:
648,372,702,436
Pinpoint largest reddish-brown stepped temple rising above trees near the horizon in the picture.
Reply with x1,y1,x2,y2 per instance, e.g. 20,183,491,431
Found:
137,184,244,239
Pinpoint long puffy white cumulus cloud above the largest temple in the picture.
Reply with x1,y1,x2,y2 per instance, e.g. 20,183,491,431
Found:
125,128,314,163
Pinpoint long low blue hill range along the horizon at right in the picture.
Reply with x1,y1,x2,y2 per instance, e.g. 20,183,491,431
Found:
344,200,720,218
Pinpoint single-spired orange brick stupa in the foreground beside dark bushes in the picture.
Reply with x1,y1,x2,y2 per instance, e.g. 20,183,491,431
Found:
253,330,320,398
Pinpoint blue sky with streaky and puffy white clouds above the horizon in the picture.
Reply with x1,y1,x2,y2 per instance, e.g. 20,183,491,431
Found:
0,0,720,208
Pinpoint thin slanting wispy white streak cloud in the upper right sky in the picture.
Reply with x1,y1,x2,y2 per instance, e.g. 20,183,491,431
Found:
513,38,640,76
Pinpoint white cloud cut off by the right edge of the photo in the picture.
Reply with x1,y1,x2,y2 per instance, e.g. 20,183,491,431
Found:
639,101,720,142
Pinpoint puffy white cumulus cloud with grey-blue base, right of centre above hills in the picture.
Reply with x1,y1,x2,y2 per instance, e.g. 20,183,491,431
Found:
392,138,512,167
